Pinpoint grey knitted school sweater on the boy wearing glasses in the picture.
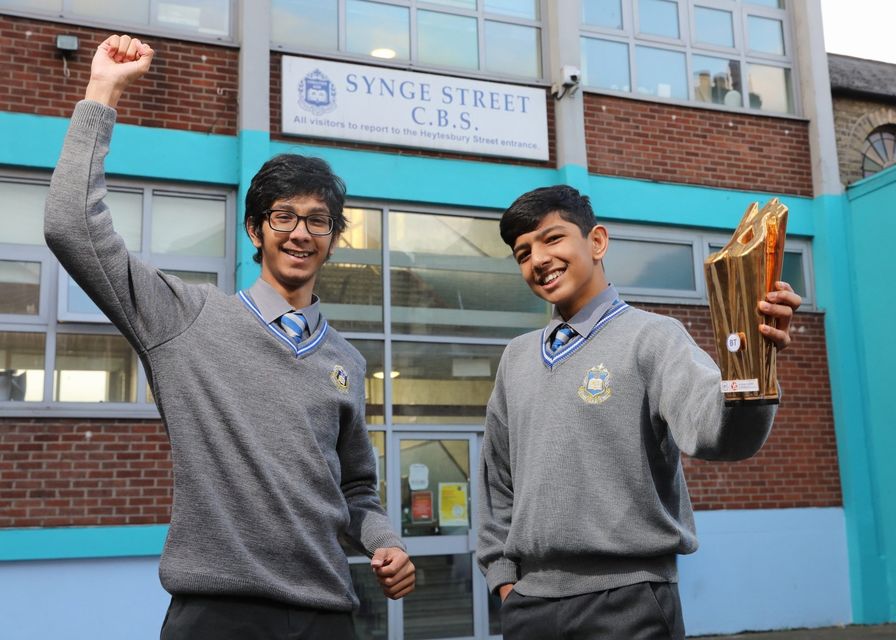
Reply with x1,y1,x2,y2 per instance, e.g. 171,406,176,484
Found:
45,101,403,611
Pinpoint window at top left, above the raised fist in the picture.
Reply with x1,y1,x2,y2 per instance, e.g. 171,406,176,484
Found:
0,0,234,41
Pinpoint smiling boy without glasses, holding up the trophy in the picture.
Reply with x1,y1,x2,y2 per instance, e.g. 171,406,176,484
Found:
477,185,801,640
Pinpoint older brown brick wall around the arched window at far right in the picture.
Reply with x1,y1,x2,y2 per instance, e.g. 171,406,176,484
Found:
833,94,896,184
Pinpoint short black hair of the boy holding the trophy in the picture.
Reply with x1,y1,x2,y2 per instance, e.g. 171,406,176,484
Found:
500,184,597,248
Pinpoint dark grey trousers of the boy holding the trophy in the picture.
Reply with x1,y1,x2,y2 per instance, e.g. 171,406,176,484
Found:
501,582,684,640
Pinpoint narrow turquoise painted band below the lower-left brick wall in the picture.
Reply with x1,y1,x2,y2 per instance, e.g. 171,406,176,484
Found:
0,525,168,562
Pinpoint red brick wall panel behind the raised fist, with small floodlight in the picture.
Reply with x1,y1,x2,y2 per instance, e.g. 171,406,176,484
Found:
0,15,239,135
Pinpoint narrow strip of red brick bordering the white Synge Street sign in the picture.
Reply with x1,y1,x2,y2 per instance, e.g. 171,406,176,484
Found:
270,52,557,168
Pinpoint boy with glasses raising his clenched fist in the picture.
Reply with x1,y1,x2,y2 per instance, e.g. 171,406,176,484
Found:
46,36,414,640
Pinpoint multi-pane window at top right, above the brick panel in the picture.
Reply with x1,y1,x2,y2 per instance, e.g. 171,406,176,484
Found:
581,0,796,114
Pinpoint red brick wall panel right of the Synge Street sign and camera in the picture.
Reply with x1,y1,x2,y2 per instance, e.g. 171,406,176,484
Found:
584,93,812,196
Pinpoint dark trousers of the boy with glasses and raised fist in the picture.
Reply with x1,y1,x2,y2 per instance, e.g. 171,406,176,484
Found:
160,595,355,640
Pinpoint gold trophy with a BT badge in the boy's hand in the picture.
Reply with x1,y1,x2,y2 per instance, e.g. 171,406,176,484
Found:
703,198,787,404
